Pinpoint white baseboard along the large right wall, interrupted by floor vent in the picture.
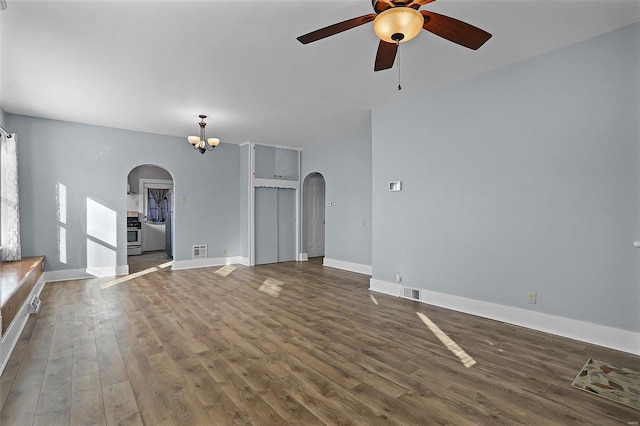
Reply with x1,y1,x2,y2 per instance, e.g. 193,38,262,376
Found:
369,278,640,355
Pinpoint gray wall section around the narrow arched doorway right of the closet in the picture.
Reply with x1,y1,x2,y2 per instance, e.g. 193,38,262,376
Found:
300,132,371,265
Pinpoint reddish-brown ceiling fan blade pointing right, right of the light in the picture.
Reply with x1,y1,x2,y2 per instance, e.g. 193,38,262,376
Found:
420,10,491,50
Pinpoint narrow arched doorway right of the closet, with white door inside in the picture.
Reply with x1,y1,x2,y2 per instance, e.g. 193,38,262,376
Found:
303,173,325,258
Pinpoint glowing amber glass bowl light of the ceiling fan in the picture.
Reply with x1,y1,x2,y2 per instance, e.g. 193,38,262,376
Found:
373,7,424,43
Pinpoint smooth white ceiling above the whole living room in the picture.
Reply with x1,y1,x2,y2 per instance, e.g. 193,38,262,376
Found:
0,0,640,147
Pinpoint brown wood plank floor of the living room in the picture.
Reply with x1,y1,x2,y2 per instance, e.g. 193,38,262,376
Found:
0,261,640,426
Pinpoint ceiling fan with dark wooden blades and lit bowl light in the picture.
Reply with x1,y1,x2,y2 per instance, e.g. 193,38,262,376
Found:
298,0,491,71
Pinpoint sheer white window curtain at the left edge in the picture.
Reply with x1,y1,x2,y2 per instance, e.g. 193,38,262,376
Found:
0,133,22,261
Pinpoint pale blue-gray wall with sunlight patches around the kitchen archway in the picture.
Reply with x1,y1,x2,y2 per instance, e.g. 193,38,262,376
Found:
6,114,240,270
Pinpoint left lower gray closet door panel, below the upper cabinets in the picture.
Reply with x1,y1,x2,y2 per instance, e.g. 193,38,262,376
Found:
255,188,278,265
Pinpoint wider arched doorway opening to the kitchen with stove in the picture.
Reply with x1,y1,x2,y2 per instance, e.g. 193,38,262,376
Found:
127,164,175,273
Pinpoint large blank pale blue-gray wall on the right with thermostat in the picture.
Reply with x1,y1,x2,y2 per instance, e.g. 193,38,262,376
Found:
372,24,640,332
